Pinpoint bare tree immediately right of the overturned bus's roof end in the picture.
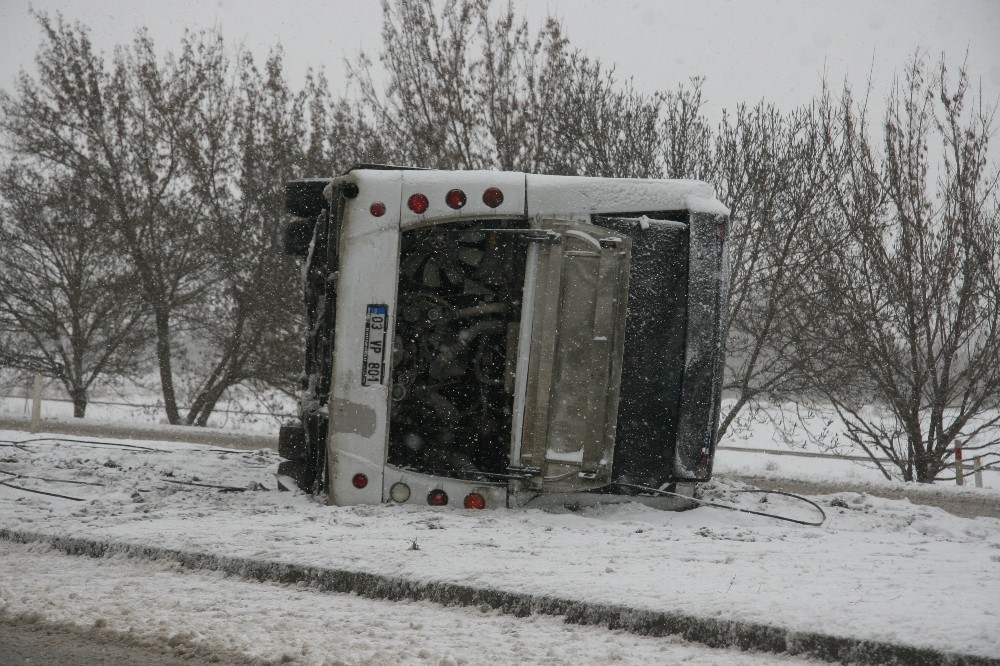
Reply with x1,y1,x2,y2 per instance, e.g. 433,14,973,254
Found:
715,103,829,437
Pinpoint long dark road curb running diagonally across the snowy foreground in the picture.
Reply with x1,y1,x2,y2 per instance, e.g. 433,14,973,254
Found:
0,528,1000,666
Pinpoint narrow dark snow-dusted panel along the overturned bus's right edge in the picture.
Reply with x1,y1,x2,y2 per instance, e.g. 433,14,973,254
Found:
674,213,729,474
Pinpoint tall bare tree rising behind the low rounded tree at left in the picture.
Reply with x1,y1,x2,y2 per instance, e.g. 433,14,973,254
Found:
0,15,222,423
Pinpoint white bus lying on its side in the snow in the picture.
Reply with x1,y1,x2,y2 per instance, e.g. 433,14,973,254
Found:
278,165,729,509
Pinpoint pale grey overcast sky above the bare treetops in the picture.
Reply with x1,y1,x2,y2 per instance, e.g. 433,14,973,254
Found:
0,0,1000,122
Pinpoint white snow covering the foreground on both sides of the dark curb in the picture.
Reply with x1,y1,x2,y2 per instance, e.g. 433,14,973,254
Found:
0,431,1000,664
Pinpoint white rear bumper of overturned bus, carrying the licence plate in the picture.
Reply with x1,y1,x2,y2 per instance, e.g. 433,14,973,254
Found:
327,171,401,505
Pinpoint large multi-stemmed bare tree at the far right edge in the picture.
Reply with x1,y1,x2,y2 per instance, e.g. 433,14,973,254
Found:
801,56,1000,482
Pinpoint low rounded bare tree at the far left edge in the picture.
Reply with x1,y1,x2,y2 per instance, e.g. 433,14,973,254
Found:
0,164,148,418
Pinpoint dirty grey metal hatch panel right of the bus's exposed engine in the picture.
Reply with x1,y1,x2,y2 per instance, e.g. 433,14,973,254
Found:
511,220,631,492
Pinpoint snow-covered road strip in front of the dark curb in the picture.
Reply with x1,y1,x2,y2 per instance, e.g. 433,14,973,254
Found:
0,542,815,665
